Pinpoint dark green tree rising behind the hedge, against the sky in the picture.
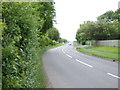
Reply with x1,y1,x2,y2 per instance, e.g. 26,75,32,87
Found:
39,2,56,33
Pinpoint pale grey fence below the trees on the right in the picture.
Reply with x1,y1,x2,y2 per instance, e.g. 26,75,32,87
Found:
93,40,120,47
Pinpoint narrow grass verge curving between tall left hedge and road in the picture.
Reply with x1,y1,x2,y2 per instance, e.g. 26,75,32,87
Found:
31,43,64,88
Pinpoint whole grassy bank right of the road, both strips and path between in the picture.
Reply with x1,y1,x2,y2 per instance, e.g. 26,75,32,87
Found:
73,42,120,61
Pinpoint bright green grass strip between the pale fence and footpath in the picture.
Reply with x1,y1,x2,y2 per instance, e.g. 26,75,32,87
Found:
89,46,120,54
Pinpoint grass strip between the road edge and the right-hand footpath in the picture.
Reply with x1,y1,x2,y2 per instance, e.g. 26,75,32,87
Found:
77,48,120,61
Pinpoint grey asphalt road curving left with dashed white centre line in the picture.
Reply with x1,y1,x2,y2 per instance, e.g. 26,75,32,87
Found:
43,44,120,88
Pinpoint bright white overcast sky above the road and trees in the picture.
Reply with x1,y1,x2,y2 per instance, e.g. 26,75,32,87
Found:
54,0,119,41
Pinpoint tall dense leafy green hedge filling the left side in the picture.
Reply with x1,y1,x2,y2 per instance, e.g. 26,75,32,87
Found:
2,2,55,88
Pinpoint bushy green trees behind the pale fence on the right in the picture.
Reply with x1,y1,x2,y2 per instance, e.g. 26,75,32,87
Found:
76,9,120,43
